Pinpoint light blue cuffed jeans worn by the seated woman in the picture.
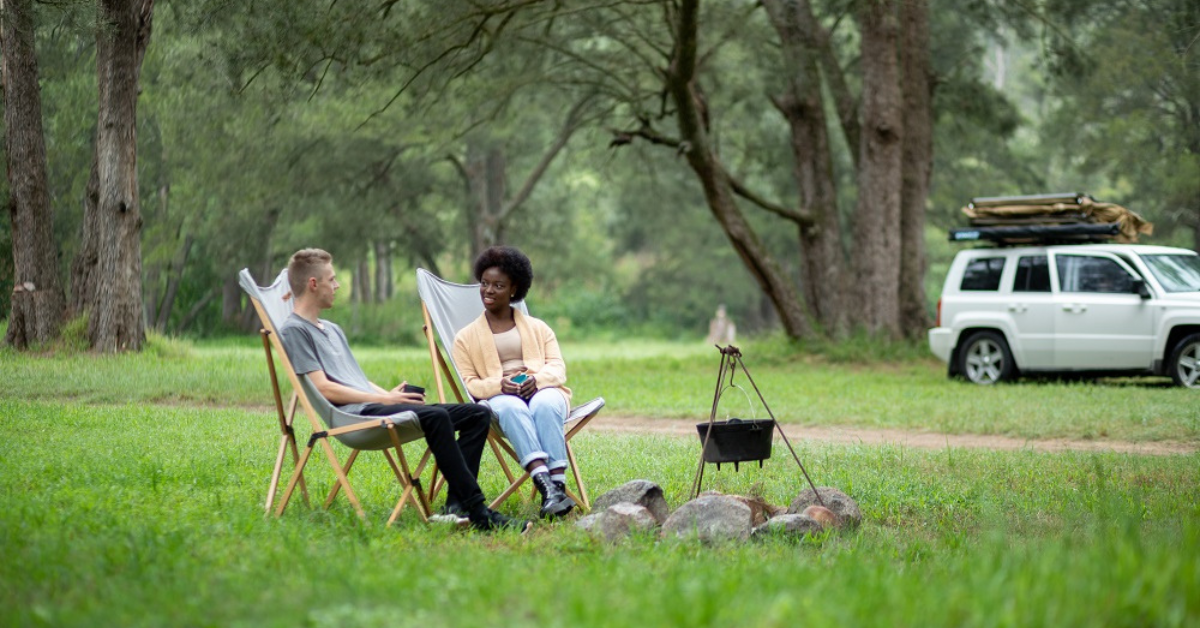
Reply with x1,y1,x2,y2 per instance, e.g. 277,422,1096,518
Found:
487,388,570,471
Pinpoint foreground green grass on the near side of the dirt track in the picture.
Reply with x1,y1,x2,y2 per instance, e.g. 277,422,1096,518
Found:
0,400,1200,626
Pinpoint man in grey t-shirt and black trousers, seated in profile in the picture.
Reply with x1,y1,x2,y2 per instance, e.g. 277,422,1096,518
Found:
280,249,532,531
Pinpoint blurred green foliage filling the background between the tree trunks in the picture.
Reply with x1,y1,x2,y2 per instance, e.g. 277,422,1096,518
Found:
0,0,1200,345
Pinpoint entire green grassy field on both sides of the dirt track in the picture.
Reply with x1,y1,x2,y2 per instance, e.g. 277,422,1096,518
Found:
0,341,1200,627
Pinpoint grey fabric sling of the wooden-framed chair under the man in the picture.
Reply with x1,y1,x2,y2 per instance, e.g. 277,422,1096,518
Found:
238,268,425,450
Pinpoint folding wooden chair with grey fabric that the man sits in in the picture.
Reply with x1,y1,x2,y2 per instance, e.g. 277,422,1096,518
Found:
238,269,431,526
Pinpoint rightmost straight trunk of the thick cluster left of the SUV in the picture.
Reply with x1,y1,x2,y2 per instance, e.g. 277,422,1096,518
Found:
899,0,934,337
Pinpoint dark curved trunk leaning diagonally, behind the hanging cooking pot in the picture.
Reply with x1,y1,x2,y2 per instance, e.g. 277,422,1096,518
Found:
667,0,811,337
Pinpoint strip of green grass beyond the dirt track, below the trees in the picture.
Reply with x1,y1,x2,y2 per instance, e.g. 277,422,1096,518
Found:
0,337,1200,443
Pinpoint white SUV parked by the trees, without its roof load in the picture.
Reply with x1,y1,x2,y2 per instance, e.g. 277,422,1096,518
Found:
929,244,1200,389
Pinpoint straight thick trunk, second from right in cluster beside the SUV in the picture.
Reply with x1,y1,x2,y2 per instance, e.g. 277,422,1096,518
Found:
854,0,904,336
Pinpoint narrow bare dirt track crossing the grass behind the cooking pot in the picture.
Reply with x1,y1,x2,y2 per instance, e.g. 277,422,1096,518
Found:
588,414,1200,455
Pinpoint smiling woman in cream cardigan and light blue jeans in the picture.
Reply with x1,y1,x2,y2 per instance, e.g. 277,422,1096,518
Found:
454,246,575,519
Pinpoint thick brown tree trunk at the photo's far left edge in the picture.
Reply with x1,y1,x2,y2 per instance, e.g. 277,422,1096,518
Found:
0,0,65,348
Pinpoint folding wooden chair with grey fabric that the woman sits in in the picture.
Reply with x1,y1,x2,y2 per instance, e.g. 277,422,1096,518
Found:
416,268,604,510
